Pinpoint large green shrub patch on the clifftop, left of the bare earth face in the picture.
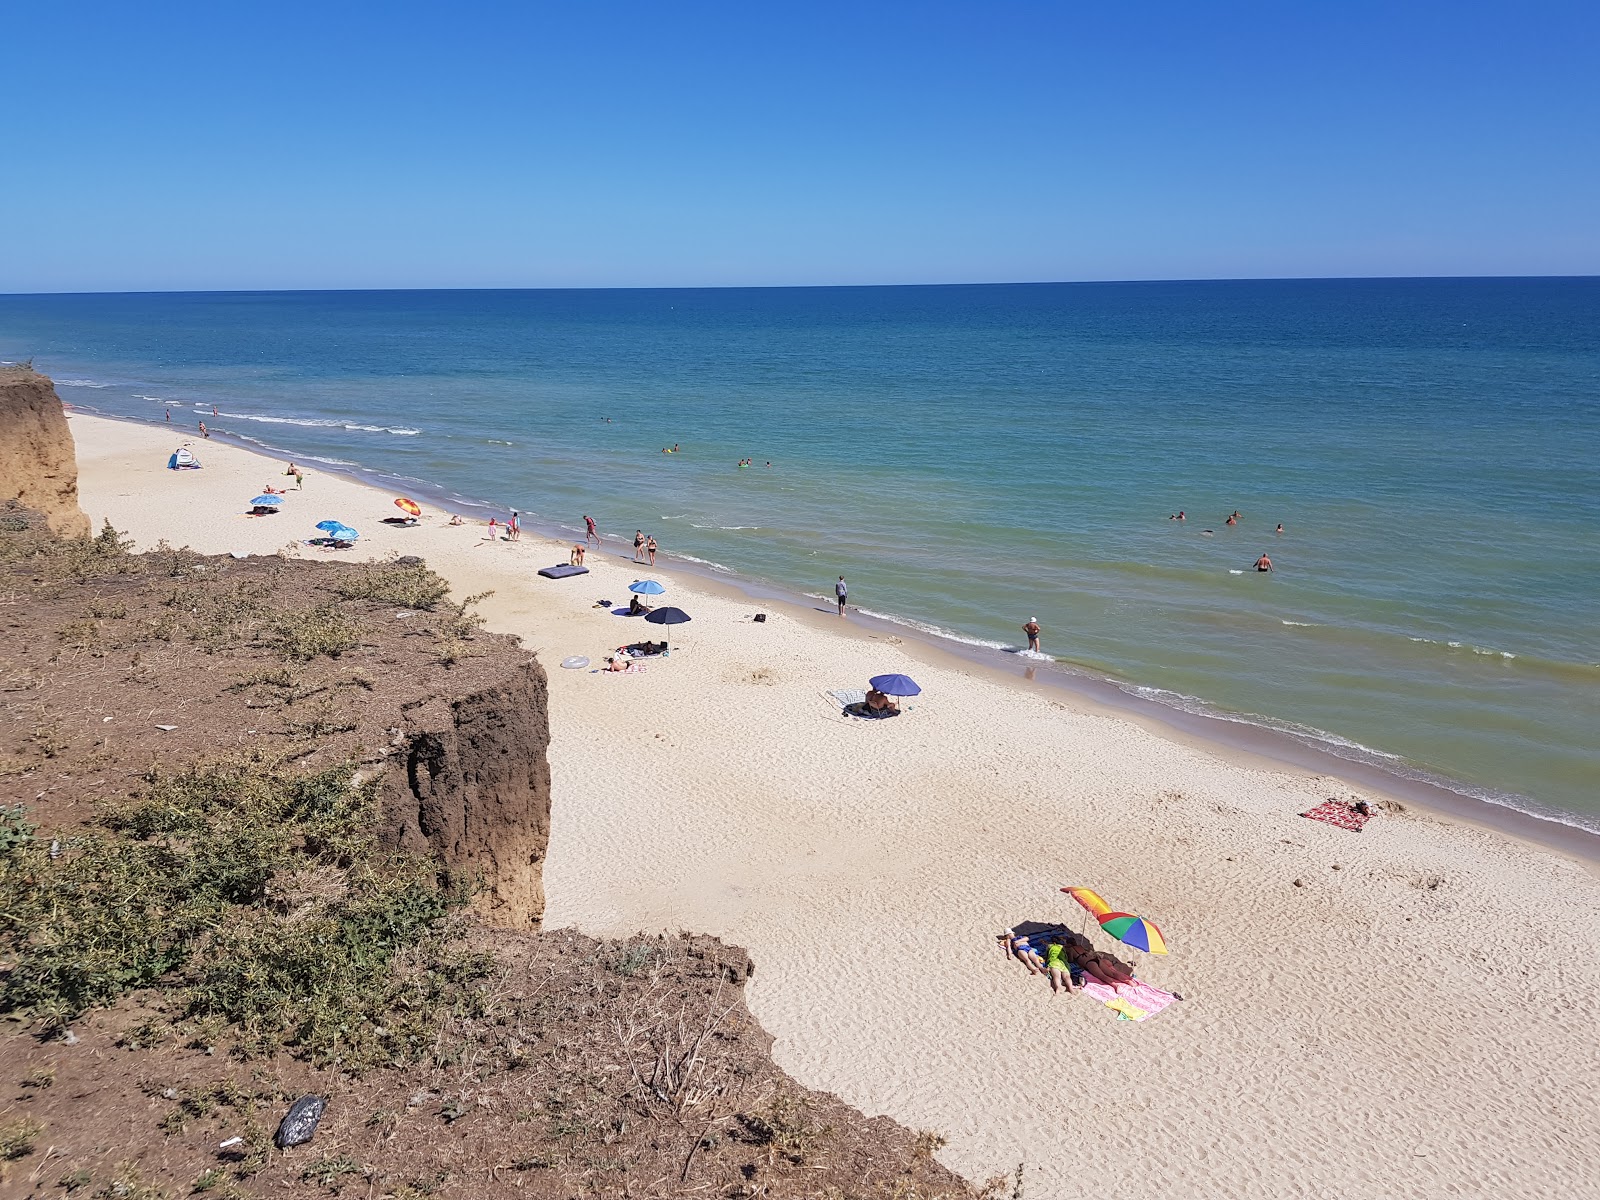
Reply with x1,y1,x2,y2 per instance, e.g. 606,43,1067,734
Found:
0,758,477,1069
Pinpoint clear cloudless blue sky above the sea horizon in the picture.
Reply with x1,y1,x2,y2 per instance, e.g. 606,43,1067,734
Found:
0,0,1600,291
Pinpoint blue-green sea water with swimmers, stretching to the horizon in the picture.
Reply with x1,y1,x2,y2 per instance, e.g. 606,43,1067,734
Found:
0,278,1600,830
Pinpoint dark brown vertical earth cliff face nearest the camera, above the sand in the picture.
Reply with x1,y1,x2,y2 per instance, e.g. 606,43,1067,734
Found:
382,659,550,928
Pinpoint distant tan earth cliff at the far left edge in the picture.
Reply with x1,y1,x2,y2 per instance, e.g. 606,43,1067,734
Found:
0,366,90,538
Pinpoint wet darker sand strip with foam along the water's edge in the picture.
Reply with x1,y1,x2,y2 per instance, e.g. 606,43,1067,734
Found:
67,405,1600,874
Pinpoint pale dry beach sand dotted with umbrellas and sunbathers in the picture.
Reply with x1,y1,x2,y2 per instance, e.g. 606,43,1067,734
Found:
72,416,1600,1200
